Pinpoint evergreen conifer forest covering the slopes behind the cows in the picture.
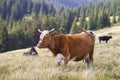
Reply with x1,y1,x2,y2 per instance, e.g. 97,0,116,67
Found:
0,0,120,52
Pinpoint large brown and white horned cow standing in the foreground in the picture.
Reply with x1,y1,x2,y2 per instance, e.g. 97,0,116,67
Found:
37,29,95,69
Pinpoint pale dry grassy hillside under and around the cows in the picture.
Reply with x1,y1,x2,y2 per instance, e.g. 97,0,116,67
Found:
0,26,120,80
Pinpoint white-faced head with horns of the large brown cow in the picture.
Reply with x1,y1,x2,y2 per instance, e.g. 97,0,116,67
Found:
37,29,57,48
